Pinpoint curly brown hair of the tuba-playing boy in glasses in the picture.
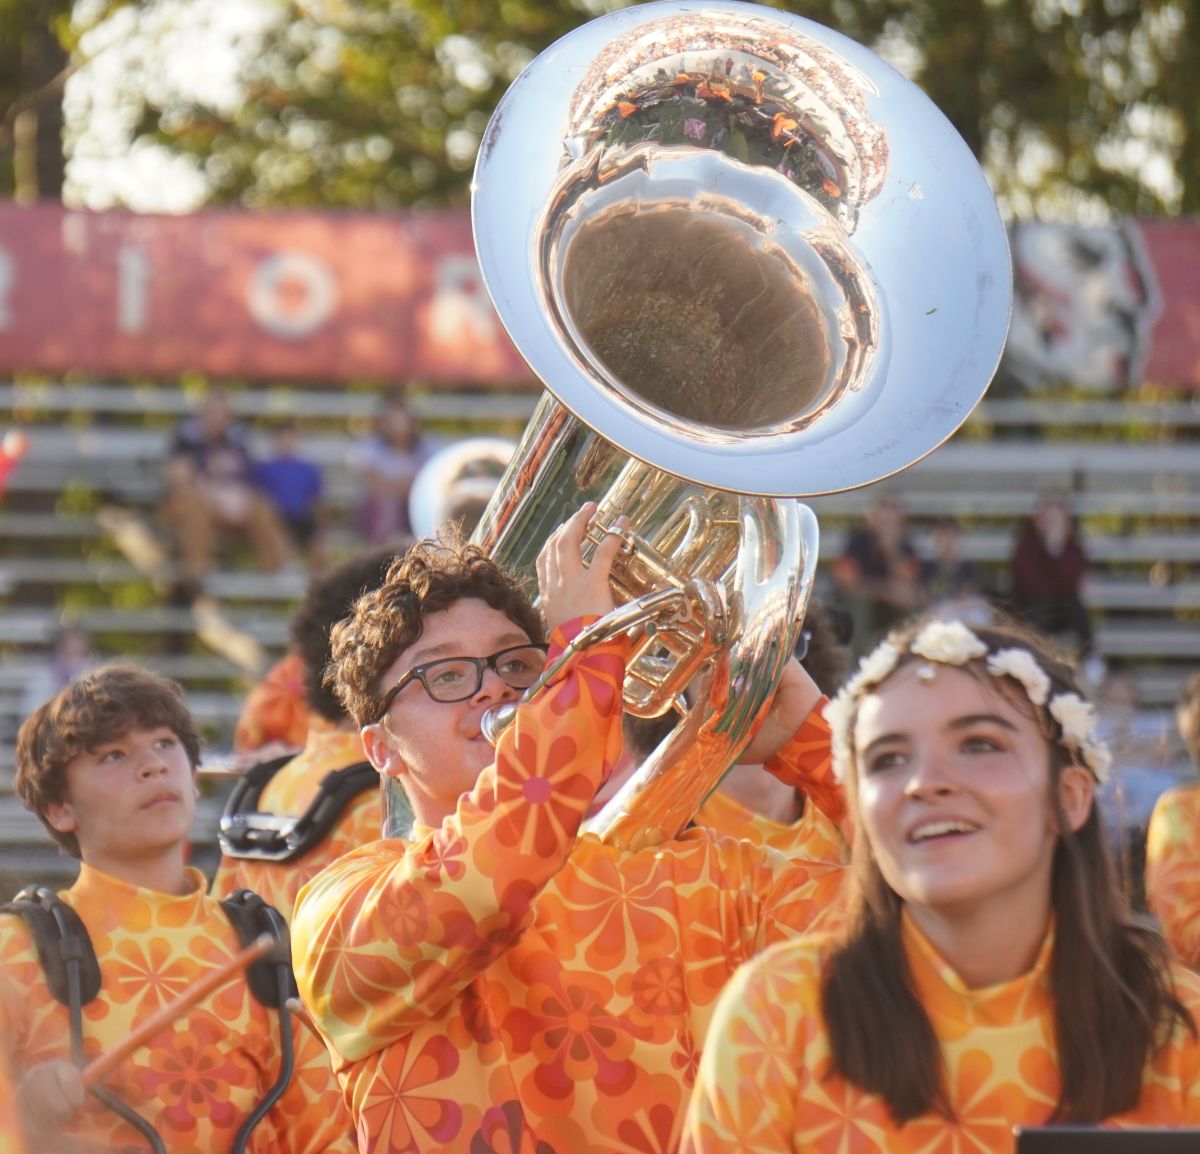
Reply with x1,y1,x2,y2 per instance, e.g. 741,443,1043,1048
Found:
325,527,545,727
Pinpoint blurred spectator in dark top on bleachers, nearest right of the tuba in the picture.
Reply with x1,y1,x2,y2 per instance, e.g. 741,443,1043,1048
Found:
833,497,920,653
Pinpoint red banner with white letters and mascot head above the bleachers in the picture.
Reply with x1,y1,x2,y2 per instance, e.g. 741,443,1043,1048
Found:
0,204,1200,395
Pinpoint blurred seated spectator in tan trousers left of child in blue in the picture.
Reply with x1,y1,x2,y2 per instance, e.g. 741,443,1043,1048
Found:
158,390,290,600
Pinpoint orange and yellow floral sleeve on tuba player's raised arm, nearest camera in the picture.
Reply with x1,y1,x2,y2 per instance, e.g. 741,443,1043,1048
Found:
292,631,629,1060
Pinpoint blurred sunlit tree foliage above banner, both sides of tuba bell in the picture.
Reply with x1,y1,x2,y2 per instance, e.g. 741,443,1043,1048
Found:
44,0,1200,218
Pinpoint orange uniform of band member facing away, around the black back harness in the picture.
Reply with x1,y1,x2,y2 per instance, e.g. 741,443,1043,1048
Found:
212,729,383,921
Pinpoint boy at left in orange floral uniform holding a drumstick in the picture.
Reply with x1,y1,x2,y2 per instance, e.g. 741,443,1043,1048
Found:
0,666,354,1154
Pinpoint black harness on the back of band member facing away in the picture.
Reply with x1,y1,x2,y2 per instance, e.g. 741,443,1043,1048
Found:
217,755,379,863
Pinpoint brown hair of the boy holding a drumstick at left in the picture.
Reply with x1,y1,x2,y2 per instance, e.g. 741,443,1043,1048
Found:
13,665,200,858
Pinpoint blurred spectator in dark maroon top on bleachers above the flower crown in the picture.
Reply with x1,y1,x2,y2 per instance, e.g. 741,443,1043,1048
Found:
1009,493,1092,656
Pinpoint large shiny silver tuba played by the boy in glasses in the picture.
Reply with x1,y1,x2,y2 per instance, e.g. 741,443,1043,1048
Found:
381,0,1012,848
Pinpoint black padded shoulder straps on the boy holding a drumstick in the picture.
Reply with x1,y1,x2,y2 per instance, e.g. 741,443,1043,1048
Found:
0,885,296,1009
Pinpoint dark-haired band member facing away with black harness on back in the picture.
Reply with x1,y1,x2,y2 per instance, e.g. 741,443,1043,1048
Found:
212,548,400,920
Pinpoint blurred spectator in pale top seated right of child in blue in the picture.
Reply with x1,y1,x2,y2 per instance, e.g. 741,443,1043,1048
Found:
350,396,438,545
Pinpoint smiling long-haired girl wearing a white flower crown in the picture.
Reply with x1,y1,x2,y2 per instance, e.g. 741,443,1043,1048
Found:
683,621,1200,1154
